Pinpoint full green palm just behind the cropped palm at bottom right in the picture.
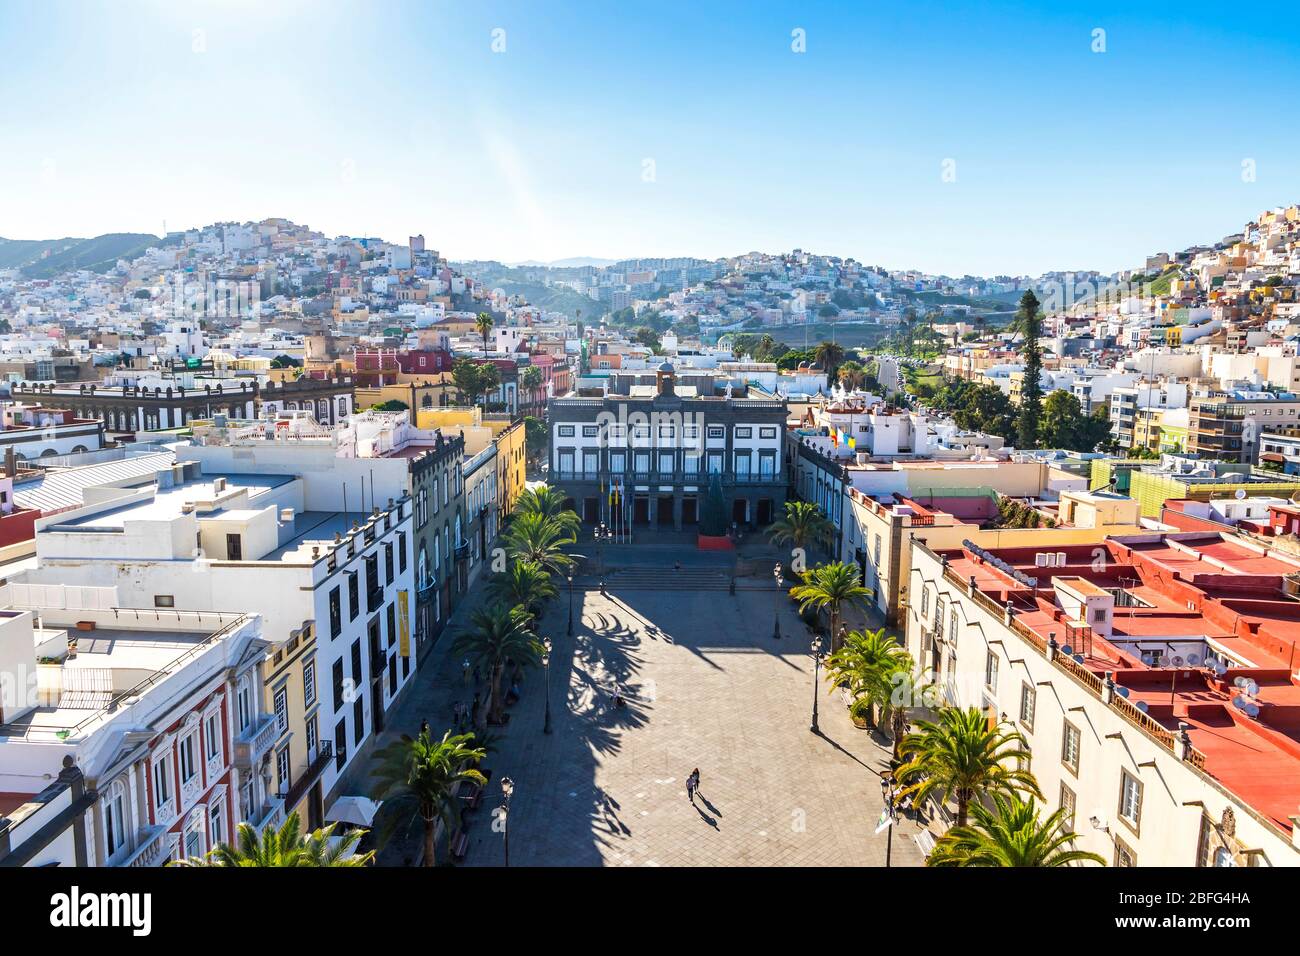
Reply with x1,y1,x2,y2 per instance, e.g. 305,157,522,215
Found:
896,708,1043,826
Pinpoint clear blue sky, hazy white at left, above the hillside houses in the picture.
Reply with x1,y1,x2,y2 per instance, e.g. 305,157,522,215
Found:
0,0,1300,274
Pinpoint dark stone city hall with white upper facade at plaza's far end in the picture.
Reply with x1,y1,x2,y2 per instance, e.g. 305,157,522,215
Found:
549,362,787,532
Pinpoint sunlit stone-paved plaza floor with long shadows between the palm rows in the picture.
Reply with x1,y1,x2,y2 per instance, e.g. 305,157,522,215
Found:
356,549,922,866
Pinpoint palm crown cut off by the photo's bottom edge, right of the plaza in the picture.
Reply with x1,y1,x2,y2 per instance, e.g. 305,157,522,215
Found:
926,793,1106,866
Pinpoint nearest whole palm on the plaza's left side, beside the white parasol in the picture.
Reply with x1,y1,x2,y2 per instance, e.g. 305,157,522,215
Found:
371,730,488,866
